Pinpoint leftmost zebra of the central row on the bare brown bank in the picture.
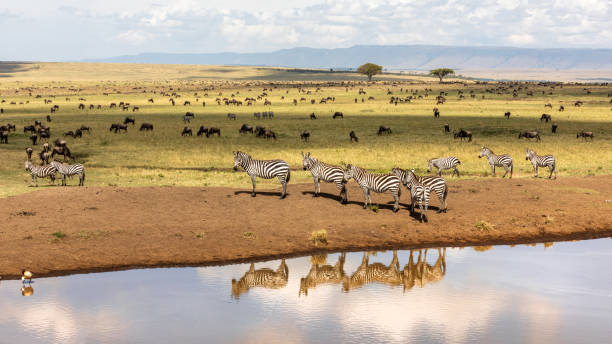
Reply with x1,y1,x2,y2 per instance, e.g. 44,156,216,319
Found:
234,152,291,199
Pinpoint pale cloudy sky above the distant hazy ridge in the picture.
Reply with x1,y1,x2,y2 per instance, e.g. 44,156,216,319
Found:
0,0,612,61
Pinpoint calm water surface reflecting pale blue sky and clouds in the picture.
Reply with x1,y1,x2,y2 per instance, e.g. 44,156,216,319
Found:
0,239,612,343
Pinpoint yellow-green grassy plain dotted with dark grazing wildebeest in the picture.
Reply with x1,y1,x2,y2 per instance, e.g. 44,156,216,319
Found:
0,64,612,197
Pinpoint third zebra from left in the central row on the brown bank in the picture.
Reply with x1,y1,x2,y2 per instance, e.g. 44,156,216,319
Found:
344,164,402,213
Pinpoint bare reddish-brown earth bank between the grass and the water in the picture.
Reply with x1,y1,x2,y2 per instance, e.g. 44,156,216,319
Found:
0,176,612,279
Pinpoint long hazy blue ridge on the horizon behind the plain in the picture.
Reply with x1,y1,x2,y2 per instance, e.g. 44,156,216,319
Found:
85,45,612,70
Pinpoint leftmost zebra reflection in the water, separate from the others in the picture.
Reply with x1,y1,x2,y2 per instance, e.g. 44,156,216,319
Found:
232,259,289,299
